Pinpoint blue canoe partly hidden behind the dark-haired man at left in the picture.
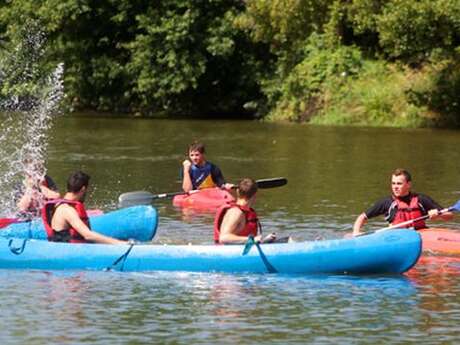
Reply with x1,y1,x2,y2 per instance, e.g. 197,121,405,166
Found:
0,205,158,242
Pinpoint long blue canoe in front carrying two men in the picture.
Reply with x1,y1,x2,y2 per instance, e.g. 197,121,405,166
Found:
0,230,421,274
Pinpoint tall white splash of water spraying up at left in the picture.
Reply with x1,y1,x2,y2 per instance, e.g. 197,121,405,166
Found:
0,24,64,216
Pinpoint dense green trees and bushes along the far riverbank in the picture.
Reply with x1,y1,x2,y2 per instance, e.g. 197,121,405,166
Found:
0,0,460,126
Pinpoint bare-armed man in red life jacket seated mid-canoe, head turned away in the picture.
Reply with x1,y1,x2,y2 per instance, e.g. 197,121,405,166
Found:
214,178,276,244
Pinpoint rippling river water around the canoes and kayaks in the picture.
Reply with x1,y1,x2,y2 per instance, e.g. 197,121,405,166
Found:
0,115,460,344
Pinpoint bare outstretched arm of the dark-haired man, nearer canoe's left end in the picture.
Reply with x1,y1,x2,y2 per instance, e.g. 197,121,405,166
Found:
60,205,127,244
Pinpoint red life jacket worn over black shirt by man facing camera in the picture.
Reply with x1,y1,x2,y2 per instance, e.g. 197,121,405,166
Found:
388,194,426,229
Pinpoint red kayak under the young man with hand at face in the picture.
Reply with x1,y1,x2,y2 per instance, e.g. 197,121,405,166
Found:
173,188,235,211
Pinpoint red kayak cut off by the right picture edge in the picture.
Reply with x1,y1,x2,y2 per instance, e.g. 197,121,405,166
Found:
419,228,460,255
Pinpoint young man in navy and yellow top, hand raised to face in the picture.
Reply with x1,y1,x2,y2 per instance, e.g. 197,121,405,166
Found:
182,142,233,193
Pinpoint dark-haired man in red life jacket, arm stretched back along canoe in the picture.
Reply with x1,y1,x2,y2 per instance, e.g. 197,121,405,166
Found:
42,171,127,244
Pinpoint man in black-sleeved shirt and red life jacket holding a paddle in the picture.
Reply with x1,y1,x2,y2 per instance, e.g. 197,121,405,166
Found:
353,169,453,236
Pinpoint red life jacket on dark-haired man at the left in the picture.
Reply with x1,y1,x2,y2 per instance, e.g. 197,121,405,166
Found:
42,199,90,243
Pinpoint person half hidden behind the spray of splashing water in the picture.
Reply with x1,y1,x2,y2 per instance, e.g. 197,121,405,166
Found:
16,160,61,219
